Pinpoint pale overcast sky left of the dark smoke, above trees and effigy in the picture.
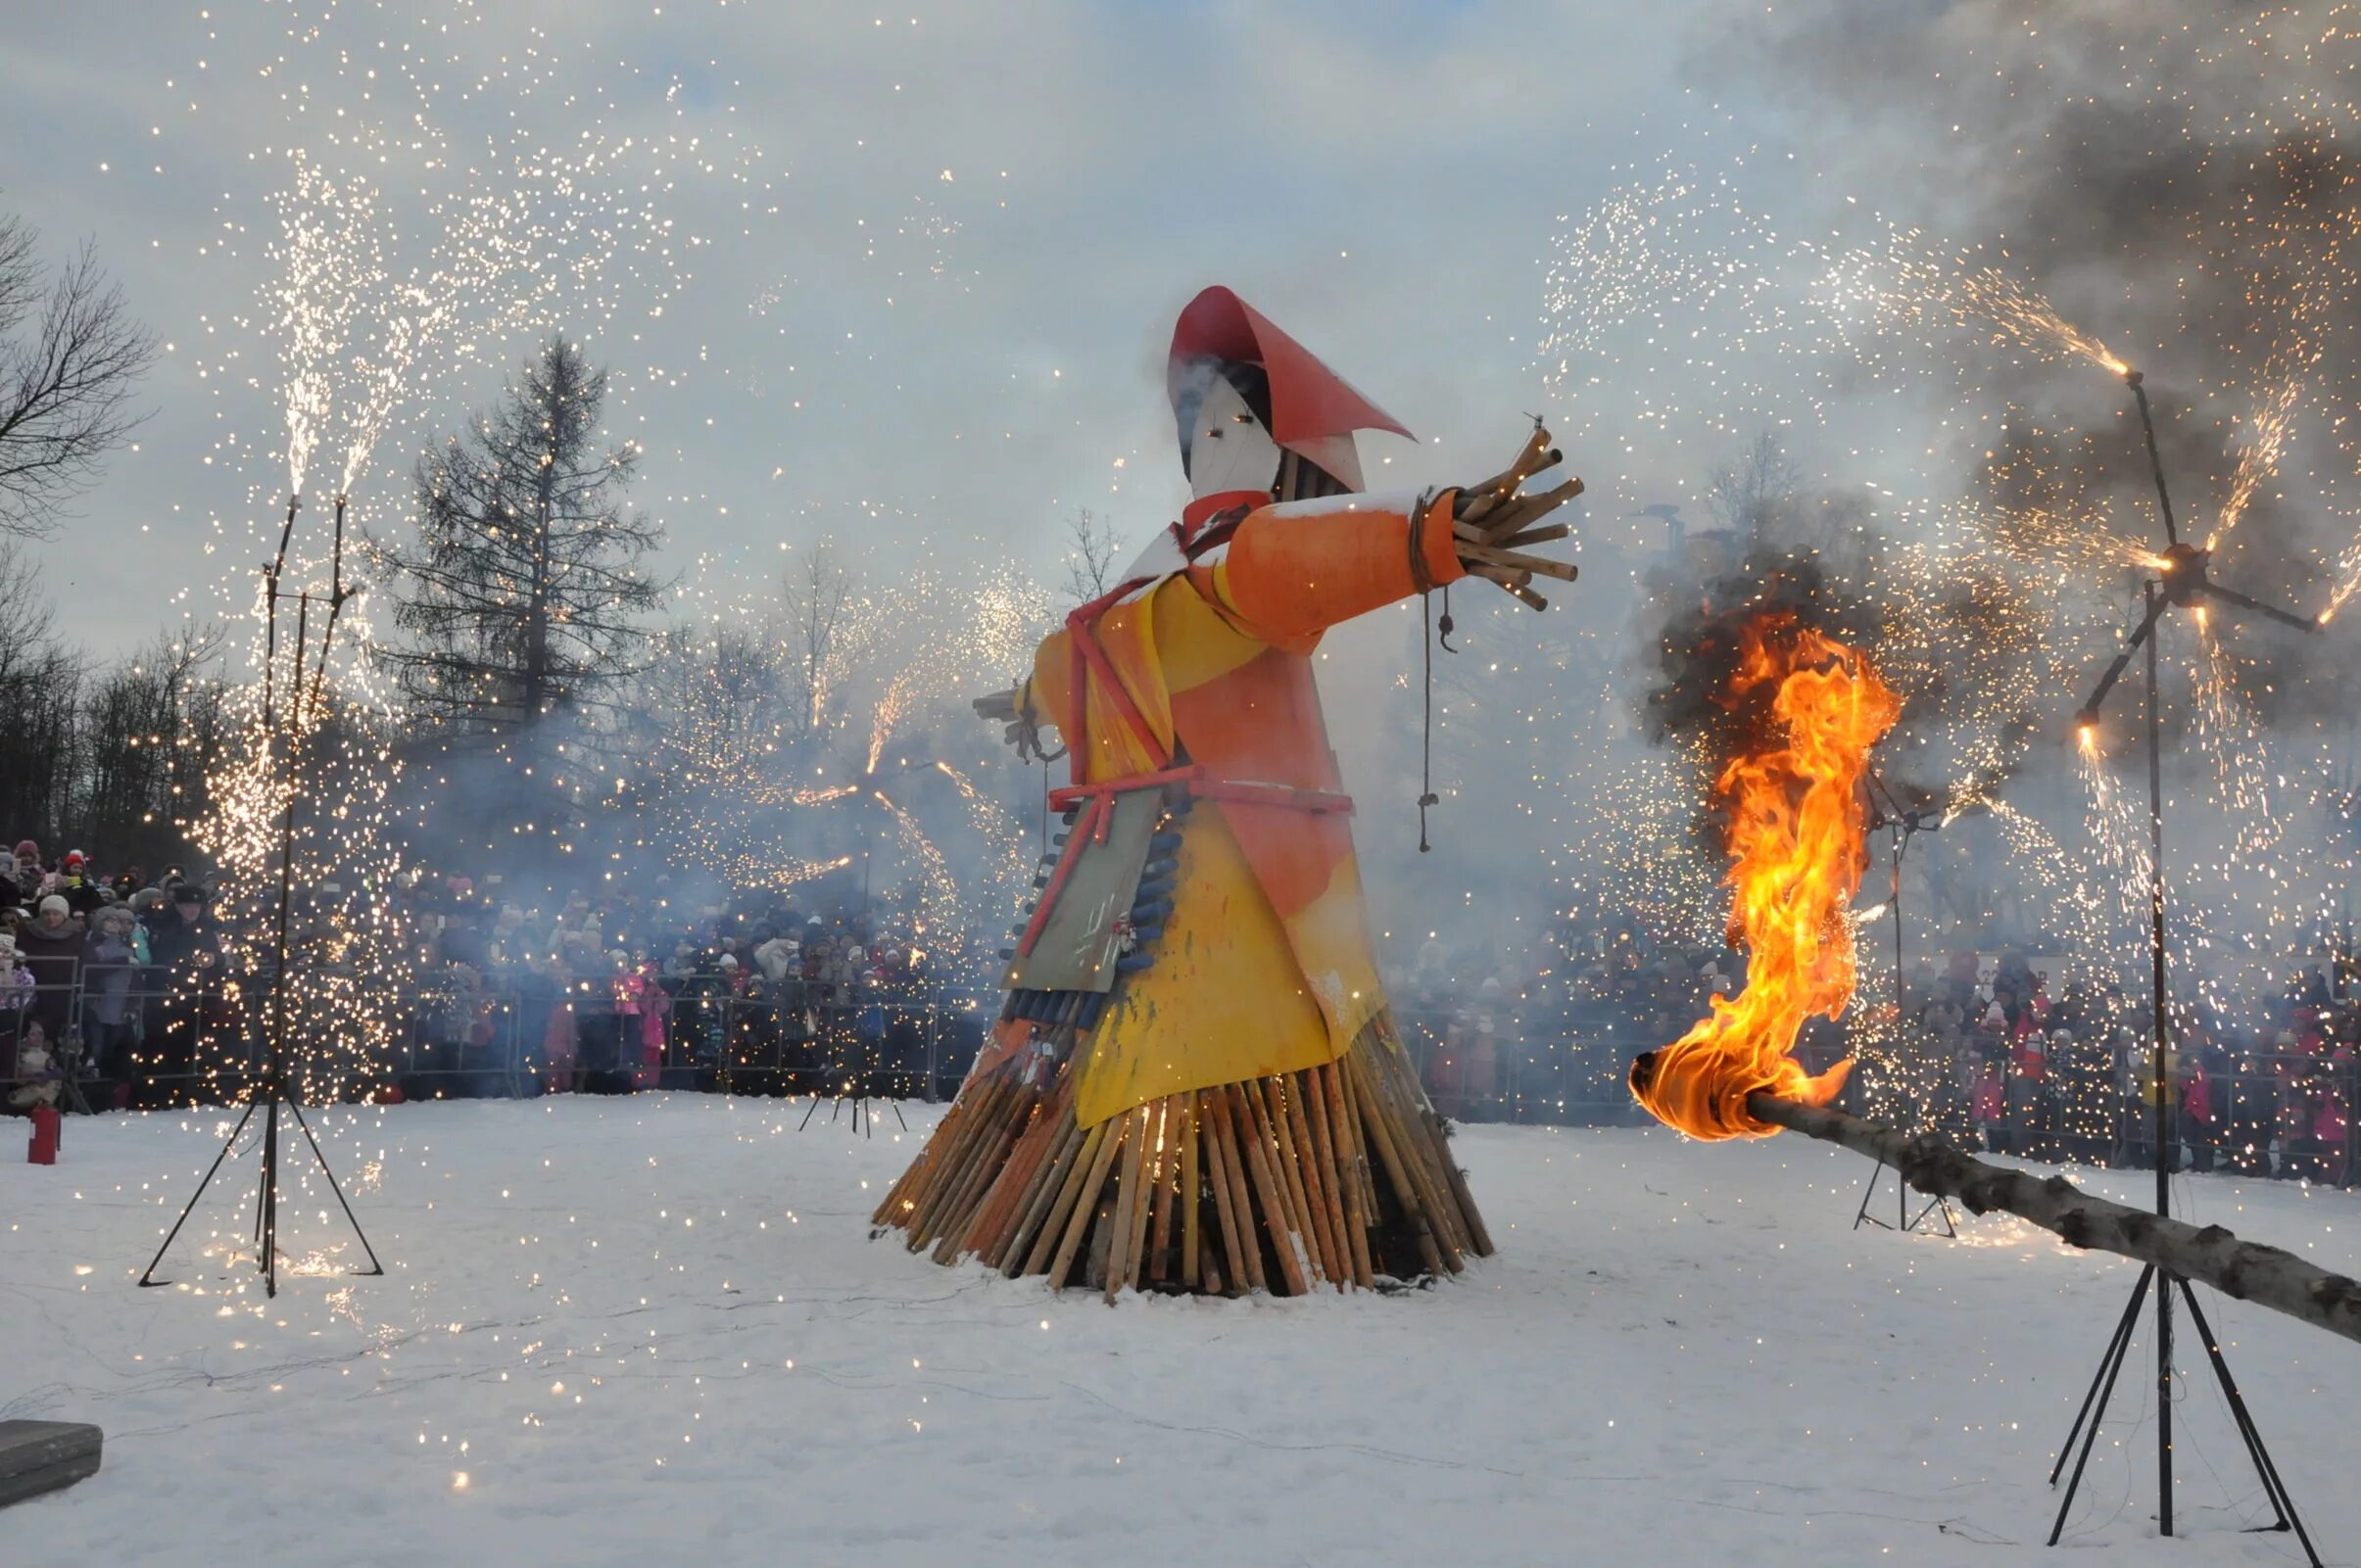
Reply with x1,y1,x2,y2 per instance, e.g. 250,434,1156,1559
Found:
0,0,1784,647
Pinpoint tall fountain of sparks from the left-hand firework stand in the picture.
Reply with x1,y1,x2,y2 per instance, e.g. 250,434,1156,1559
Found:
174,0,797,1096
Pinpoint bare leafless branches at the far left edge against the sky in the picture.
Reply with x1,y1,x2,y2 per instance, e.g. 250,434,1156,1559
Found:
0,213,156,539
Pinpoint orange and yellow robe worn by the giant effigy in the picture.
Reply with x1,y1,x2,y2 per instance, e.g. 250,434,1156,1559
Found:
1020,492,1464,1126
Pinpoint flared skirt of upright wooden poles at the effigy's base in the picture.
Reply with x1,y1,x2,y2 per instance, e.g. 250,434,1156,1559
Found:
871,1022,1492,1302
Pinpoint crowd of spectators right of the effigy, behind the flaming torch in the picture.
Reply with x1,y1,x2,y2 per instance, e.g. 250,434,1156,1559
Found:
1388,919,2361,1185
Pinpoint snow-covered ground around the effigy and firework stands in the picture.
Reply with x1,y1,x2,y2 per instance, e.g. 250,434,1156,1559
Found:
0,1096,2361,1568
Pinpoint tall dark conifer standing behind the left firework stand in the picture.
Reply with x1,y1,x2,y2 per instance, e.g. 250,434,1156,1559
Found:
382,335,663,735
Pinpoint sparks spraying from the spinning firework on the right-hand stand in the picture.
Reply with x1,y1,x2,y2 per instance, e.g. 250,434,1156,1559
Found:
1535,33,2361,1029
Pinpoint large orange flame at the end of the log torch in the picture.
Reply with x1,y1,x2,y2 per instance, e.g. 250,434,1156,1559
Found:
1631,611,1901,1138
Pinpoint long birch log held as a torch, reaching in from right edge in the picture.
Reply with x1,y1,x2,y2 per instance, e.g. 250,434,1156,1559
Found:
1747,1093,2361,1342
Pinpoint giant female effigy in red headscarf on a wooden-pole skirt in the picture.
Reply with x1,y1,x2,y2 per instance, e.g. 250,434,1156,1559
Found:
876,288,1582,1299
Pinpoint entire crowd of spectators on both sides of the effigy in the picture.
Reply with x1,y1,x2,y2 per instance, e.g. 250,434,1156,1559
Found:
0,840,2361,1183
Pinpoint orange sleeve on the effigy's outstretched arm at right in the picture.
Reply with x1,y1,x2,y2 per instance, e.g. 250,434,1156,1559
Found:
1211,492,1467,647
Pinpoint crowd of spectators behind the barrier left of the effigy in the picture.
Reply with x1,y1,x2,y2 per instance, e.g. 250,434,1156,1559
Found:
0,840,978,1113
